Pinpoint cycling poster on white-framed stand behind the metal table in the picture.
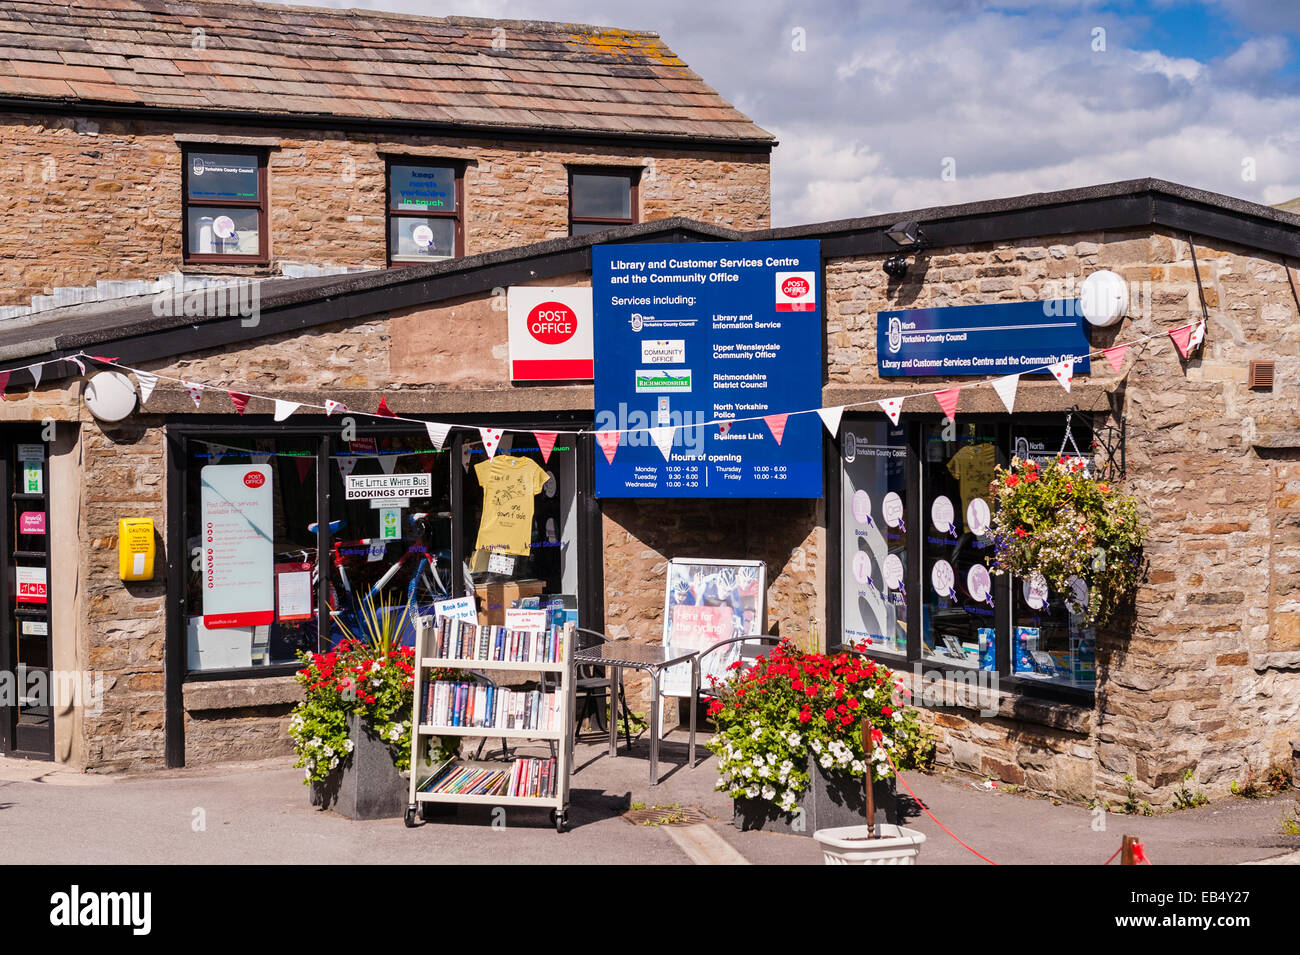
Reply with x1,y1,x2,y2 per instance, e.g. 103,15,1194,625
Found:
659,557,767,696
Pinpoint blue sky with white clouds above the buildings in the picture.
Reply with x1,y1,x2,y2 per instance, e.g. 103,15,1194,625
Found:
292,0,1300,226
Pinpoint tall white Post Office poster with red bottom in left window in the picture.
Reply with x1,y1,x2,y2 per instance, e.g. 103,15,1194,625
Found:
200,464,276,630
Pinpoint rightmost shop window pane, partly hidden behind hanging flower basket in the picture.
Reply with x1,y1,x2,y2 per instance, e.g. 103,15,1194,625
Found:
1011,425,1097,689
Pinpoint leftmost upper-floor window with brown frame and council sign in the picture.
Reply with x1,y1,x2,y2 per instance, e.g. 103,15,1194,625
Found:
182,148,270,265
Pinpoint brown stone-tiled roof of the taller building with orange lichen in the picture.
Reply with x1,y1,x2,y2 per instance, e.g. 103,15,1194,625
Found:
0,0,774,146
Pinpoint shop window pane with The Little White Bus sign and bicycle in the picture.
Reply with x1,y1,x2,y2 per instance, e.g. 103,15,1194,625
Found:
329,434,454,646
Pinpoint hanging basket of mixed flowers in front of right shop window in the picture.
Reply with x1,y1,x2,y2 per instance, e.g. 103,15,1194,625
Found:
989,456,1145,626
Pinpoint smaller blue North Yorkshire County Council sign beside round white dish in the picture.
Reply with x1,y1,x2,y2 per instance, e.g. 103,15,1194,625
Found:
876,299,1091,378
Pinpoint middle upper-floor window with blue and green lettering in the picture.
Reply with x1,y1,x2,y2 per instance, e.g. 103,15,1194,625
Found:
387,160,464,264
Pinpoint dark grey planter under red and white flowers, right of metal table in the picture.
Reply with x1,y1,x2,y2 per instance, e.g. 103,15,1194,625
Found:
732,759,898,835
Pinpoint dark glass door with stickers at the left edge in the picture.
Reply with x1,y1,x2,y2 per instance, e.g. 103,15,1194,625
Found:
0,430,55,760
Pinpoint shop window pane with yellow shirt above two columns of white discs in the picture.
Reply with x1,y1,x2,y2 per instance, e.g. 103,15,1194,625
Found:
919,421,997,667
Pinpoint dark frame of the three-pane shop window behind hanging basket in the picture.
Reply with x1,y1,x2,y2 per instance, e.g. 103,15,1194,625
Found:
824,413,1100,707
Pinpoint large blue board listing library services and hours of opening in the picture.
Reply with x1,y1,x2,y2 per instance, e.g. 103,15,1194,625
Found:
592,240,822,498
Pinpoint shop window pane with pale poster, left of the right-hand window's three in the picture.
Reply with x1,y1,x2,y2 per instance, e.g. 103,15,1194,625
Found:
841,421,907,655
